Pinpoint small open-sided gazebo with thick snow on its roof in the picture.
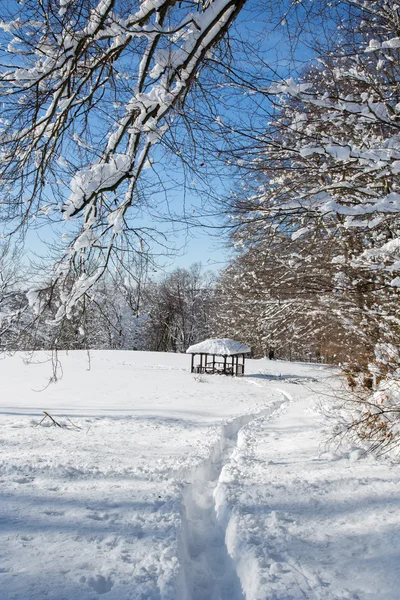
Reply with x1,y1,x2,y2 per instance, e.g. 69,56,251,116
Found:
186,338,250,376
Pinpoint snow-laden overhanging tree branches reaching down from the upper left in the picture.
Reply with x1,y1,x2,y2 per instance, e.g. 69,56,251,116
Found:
0,0,245,321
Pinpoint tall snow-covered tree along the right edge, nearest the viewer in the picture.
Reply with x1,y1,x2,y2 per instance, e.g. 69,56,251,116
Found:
219,0,400,448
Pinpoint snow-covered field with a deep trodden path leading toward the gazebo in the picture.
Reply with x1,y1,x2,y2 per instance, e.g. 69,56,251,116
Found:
0,352,400,600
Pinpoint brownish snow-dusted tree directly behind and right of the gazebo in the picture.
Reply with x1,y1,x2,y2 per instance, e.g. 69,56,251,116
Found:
214,223,376,364
